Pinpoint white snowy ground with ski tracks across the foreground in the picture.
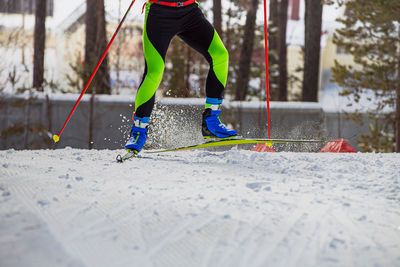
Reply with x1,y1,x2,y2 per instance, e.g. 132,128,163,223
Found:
0,148,400,267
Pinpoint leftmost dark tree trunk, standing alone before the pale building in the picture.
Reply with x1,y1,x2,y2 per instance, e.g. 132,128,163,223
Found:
33,0,46,91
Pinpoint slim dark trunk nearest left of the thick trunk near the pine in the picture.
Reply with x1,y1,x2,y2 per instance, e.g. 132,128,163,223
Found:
278,0,288,101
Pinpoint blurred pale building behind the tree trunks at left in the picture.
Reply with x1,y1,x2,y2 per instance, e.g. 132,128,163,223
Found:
0,0,144,93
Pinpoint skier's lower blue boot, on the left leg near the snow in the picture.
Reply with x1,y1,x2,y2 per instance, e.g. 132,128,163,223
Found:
125,116,150,154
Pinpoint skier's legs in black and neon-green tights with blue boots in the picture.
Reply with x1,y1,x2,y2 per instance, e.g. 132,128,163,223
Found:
125,3,237,152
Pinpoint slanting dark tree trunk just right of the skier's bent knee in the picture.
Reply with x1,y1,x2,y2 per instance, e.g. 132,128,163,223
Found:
235,0,258,100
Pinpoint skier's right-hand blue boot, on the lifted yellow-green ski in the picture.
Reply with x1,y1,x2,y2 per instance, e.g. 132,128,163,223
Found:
201,97,237,139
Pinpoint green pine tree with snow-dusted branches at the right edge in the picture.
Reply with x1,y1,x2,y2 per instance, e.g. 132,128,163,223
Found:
332,0,400,152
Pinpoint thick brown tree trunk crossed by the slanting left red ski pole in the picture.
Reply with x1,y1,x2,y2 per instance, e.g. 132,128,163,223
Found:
85,0,111,94
